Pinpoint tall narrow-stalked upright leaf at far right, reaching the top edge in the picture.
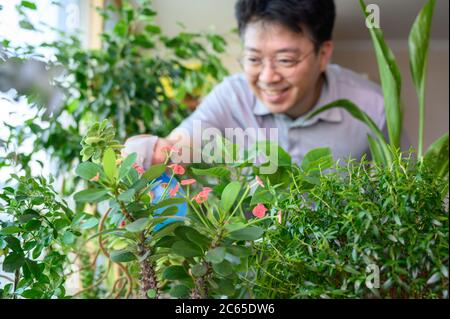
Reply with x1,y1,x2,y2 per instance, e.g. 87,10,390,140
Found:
408,0,436,158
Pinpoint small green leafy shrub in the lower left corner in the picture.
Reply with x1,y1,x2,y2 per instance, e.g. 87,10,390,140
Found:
0,175,74,299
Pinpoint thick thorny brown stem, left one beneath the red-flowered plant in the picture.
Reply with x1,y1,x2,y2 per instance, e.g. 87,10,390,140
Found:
138,233,160,299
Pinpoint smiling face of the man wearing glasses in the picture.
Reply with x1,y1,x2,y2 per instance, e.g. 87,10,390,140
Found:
243,22,332,117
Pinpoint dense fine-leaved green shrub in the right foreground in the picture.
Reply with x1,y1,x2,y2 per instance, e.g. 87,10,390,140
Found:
254,156,449,298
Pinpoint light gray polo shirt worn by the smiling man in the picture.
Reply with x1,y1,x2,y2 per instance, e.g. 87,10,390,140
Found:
176,65,385,163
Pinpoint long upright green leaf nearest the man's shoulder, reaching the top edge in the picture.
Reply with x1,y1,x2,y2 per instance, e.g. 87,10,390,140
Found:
360,0,403,148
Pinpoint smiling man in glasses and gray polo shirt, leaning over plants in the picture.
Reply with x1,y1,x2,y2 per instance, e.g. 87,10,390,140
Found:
125,0,392,168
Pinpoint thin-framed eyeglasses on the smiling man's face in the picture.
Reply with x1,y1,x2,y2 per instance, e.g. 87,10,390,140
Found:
239,50,315,77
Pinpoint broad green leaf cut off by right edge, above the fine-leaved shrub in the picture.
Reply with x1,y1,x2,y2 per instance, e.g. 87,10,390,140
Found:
423,133,448,178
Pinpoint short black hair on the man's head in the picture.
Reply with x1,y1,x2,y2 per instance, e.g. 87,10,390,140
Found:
235,0,336,48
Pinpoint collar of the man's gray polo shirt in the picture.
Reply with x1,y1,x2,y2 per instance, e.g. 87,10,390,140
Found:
253,68,342,127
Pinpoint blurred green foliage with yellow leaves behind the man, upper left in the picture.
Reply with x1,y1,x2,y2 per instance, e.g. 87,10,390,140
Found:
0,0,228,185
